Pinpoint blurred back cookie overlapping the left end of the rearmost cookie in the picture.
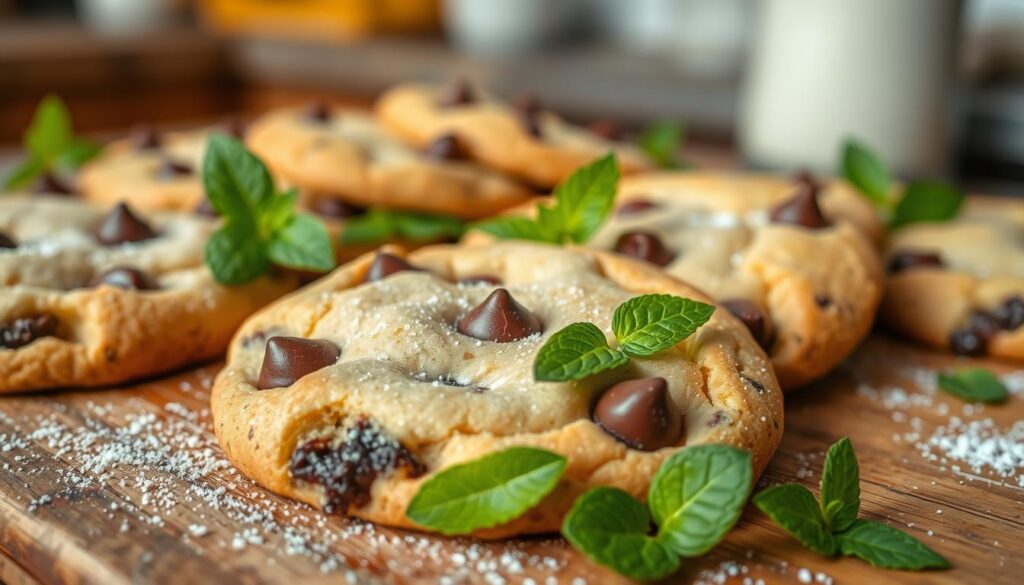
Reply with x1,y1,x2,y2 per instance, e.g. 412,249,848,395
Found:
246,103,532,218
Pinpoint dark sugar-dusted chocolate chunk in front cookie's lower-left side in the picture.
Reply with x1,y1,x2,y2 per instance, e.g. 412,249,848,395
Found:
289,419,424,514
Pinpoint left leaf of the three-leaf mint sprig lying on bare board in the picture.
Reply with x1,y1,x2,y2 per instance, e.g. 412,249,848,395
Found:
754,484,836,556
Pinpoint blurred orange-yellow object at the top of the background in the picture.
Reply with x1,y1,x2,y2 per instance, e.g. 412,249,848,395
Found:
197,0,439,40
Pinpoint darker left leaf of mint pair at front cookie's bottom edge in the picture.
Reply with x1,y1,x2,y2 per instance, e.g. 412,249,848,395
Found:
562,488,679,580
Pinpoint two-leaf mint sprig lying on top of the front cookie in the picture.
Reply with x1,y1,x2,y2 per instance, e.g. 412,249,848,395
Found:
534,294,715,382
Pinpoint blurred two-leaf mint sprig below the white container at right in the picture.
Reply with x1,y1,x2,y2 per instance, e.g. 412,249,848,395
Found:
840,138,964,227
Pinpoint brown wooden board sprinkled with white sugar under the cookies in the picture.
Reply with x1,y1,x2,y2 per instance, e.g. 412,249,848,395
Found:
0,335,1024,585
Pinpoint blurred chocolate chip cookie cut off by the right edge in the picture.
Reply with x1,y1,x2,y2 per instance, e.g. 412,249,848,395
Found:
881,199,1024,360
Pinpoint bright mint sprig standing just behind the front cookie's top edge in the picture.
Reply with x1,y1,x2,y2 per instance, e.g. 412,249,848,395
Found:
471,153,618,244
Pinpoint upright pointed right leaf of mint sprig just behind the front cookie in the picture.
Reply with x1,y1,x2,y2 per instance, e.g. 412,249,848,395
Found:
552,153,618,244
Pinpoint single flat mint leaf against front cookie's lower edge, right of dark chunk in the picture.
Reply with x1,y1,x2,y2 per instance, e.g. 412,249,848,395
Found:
406,447,565,535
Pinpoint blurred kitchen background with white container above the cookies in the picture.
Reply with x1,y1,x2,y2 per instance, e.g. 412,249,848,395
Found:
0,0,1024,195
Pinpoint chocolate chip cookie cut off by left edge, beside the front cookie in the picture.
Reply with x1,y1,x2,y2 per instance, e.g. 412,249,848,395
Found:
0,195,294,392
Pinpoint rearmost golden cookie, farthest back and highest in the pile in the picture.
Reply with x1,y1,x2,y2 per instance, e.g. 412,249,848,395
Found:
377,84,653,187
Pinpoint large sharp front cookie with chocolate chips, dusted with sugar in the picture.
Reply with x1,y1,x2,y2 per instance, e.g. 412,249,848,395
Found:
212,243,782,537
